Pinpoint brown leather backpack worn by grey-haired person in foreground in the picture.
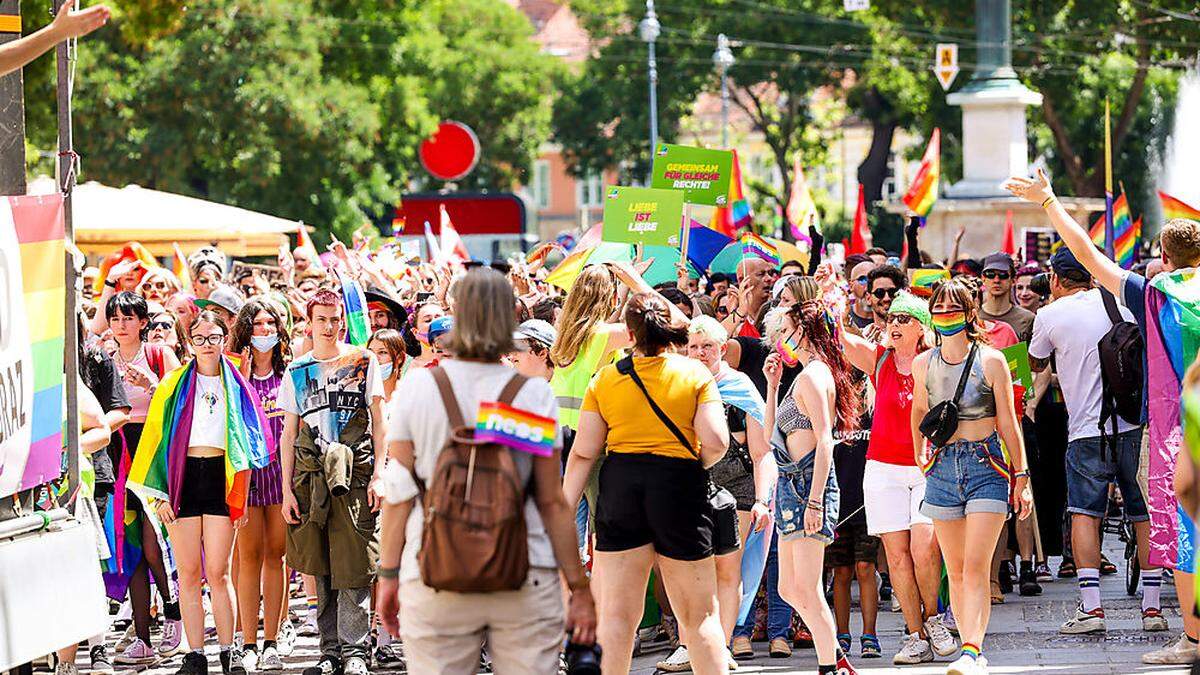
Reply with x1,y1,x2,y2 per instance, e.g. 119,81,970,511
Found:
414,368,529,593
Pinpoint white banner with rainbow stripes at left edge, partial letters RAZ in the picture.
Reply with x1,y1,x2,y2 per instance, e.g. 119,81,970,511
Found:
0,193,66,497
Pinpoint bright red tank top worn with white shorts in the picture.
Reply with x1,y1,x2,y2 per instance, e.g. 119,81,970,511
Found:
866,347,912,466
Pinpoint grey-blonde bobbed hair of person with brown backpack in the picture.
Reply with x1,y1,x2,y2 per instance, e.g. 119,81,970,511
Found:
446,267,517,363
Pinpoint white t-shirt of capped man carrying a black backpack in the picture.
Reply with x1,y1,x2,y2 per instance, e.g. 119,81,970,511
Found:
1030,288,1135,441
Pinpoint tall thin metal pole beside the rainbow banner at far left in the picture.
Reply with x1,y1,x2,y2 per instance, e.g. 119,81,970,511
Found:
54,2,79,498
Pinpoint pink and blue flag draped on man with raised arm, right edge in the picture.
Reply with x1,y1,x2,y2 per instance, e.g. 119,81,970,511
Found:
1146,269,1200,567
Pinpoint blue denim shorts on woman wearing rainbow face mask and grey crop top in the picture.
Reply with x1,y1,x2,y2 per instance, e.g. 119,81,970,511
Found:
920,434,1012,520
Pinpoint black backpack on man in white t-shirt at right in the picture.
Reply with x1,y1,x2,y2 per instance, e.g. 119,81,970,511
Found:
1096,288,1146,456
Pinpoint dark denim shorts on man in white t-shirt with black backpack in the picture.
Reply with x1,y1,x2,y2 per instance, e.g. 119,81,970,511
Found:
1067,429,1150,522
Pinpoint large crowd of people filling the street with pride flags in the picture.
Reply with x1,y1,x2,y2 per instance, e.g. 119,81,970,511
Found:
51,169,1200,675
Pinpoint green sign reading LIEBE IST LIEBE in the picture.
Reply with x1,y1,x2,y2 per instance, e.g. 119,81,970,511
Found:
600,185,683,246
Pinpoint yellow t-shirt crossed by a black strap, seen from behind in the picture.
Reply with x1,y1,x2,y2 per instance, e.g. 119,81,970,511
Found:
582,354,721,459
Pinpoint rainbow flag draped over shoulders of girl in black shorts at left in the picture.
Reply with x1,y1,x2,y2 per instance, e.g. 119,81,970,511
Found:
126,358,276,523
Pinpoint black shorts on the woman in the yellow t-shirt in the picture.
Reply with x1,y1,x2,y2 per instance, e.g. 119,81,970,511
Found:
595,453,713,561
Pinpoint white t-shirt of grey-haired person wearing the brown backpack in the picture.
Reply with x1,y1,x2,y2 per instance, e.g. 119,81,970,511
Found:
388,359,562,581
